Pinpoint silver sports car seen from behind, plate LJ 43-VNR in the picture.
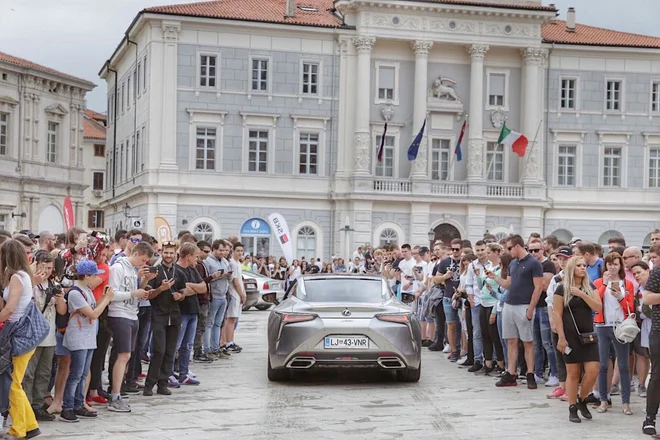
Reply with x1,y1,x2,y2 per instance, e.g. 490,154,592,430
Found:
263,274,422,382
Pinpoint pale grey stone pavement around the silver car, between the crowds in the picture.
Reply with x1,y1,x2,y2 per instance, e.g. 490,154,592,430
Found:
39,311,648,440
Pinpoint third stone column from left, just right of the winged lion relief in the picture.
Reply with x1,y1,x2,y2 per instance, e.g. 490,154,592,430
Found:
467,44,489,195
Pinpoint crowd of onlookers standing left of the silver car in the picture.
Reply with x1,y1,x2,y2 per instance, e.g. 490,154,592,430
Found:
0,227,248,439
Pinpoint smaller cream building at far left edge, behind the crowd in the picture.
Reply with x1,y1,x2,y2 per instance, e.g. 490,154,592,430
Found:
0,53,94,233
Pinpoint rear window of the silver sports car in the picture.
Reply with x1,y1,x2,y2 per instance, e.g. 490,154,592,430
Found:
297,278,390,303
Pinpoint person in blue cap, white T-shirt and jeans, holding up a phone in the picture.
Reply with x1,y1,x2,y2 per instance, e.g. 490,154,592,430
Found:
60,260,114,422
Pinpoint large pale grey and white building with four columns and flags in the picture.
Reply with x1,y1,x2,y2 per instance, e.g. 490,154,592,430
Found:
101,0,660,258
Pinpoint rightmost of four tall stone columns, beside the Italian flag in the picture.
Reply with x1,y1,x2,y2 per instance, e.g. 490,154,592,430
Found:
520,47,547,184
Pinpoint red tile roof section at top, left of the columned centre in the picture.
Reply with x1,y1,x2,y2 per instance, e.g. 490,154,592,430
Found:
144,0,341,27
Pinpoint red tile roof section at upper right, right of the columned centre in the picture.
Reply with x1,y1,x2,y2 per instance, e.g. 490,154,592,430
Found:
541,20,660,49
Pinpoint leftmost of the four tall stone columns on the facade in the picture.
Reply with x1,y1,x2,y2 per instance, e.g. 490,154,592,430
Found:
353,35,376,176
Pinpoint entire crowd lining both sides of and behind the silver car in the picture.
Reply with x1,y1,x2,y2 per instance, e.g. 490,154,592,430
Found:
0,228,660,438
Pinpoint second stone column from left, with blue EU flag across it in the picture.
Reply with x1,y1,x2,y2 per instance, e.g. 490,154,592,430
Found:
411,40,433,179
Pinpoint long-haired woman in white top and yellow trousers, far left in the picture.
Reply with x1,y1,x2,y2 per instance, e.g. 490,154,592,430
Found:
0,240,40,438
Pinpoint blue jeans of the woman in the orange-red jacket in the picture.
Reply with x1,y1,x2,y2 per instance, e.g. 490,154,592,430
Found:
596,326,630,404
